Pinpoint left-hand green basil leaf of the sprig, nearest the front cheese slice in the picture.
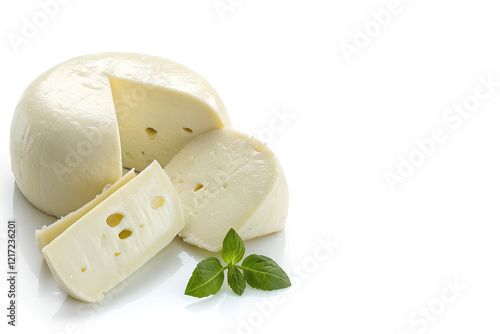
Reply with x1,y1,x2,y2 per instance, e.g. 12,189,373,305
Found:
184,257,224,298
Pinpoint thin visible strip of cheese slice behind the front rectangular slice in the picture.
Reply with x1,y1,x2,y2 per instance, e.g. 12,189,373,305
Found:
35,169,135,251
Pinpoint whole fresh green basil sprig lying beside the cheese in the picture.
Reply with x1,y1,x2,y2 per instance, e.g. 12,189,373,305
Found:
184,228,291,298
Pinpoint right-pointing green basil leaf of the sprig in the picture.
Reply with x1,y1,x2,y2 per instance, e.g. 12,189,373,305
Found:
240,254,291,290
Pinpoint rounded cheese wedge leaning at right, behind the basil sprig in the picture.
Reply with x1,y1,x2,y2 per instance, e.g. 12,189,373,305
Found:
165,129,288,252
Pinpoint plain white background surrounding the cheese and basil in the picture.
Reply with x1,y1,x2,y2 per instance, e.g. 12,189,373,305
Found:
0,0,500,334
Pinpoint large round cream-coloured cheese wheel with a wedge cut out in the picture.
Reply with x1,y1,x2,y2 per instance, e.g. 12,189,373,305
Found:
10,53,231,217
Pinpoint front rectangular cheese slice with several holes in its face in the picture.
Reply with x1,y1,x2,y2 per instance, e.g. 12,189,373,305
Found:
42,161,184,302
